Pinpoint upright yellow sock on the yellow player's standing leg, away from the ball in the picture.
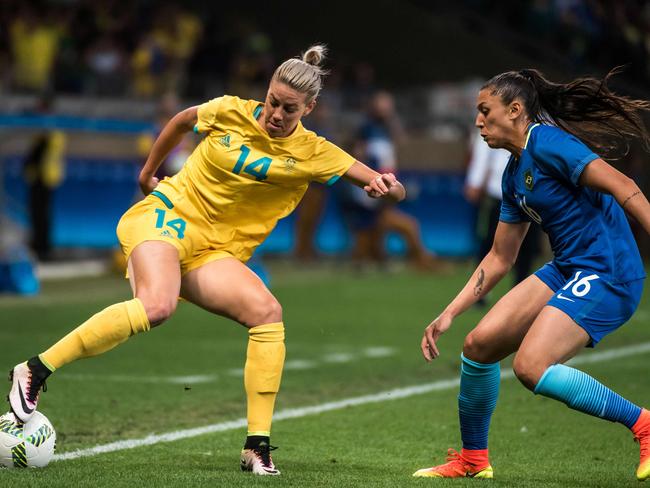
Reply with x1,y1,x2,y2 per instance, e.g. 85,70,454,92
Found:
244,322,285,436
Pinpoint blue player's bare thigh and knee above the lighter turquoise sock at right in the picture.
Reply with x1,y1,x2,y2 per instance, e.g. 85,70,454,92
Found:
513,307,591,390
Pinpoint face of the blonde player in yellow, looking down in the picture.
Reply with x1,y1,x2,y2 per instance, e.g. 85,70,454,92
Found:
260,80,316,137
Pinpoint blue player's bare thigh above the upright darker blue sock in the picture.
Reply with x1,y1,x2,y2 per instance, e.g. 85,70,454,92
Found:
463,275,553,363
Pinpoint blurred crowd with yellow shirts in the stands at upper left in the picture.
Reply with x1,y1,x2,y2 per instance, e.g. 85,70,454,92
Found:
0,0,380,104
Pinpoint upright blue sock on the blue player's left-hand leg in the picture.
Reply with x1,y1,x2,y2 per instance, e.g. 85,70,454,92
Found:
458,354,501,449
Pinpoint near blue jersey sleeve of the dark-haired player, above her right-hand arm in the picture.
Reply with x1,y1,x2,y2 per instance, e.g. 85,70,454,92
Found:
527,125,598,186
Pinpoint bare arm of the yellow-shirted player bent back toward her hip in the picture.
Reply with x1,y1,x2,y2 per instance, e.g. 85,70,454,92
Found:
138,106,198,195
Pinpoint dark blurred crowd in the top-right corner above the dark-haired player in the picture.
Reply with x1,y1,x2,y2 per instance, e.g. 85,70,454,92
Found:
454,0,650,85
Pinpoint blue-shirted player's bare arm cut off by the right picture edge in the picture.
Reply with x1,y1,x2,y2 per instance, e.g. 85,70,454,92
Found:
579,158,650,234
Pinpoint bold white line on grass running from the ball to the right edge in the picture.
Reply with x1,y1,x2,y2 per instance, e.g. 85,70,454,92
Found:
54,342,650,461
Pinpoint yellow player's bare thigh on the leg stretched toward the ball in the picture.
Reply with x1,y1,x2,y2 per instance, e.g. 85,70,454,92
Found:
127,241,181,327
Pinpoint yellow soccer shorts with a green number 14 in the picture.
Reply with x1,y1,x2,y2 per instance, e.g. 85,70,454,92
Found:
117,190,236,274
